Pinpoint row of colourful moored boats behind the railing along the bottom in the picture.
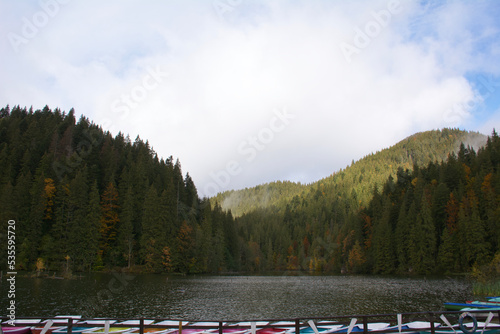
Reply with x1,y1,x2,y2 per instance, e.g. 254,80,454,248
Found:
0,309,500,334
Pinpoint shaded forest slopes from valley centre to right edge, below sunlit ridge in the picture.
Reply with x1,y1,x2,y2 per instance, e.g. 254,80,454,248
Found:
237,131,500,274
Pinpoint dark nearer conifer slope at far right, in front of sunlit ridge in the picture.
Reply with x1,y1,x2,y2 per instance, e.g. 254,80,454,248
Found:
360,136,500,273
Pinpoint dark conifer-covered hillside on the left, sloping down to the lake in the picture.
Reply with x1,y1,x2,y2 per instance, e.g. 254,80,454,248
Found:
0,107,239,272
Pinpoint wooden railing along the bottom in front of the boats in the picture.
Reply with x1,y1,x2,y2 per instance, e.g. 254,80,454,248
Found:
0,309,500,334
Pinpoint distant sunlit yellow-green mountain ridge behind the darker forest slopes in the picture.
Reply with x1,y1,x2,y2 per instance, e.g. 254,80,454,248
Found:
211,128,487,217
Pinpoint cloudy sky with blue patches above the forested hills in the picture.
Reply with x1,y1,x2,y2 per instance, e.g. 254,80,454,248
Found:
0,0,500,196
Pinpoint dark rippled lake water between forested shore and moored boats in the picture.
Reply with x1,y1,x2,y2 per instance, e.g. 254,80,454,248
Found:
0,274,472,320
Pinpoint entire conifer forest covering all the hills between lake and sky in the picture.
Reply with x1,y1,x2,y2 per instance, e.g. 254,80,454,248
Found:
0,106,500,274
